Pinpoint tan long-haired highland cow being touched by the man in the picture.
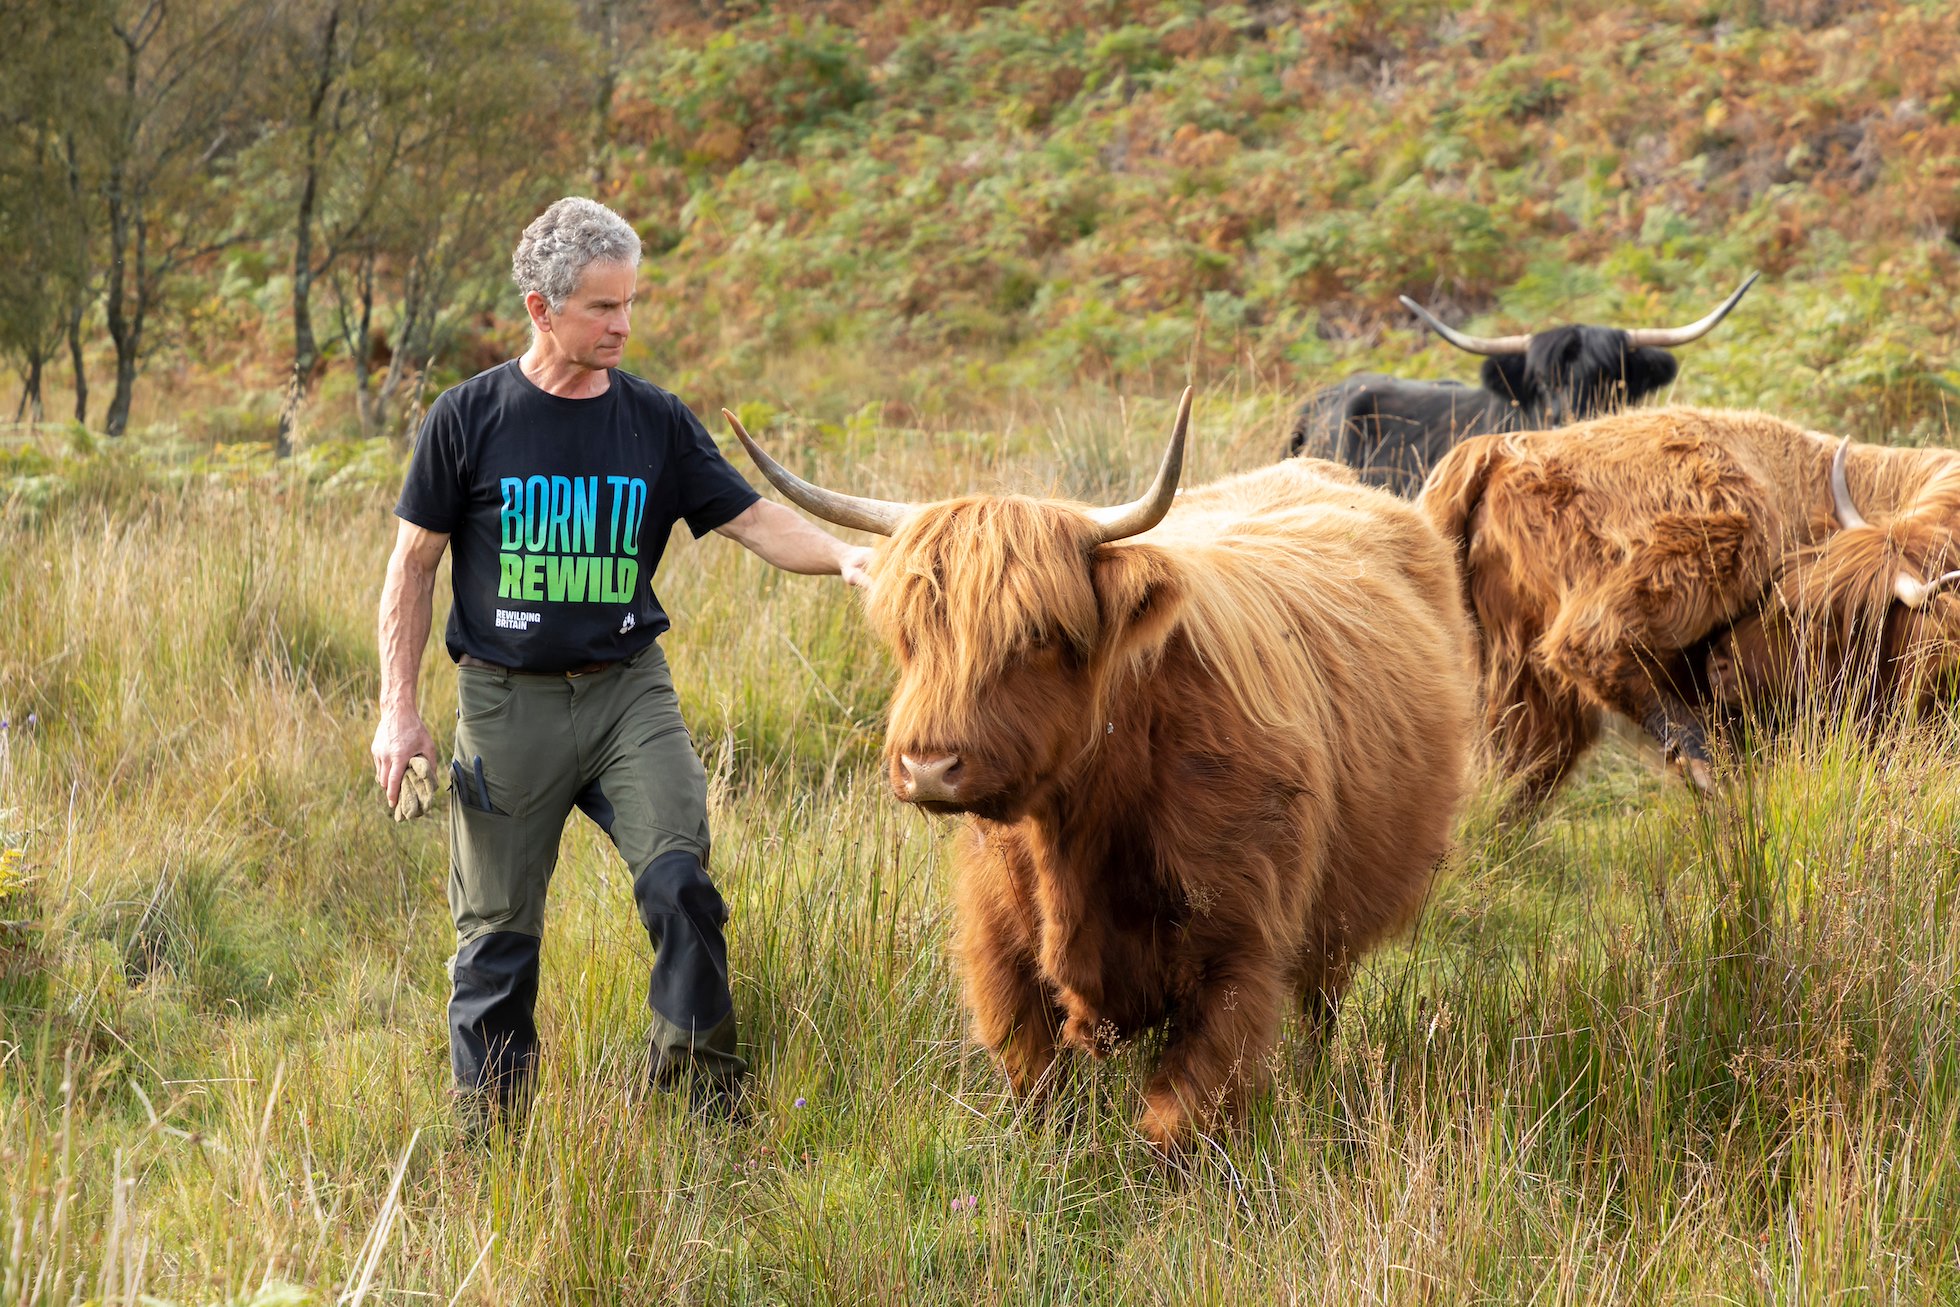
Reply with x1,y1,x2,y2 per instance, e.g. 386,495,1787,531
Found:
729,392,1474,1150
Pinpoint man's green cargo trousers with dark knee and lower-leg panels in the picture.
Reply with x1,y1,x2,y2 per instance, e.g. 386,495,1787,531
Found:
449,645,747,1107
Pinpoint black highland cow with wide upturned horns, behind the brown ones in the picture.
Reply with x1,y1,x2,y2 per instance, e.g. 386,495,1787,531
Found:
1286,274,1756,496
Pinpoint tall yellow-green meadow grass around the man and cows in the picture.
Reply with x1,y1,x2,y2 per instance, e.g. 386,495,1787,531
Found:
0,401,1960,1307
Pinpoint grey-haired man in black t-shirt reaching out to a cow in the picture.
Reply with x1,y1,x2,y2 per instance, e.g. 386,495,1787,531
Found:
372,198,870,1129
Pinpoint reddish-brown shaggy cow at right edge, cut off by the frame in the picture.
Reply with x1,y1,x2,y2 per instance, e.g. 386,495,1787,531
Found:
1419,408,1960,799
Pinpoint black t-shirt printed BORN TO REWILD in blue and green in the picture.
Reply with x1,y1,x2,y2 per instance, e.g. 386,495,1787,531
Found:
394,361,760,672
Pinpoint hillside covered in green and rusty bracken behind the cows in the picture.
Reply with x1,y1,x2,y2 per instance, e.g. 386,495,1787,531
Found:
613,0,1960,435
